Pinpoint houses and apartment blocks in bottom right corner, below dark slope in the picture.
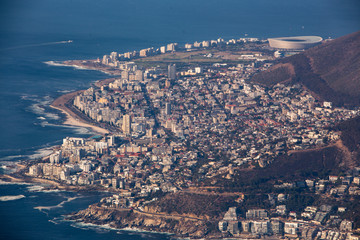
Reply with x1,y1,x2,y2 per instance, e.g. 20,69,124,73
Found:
218,170,360,240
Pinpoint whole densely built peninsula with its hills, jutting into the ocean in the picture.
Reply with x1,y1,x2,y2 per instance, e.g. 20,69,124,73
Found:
1,32,360,240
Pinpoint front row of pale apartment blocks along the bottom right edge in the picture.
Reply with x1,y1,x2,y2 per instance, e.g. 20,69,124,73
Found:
218,205,359,240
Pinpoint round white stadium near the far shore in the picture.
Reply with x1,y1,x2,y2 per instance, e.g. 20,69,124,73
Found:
268,36,323,50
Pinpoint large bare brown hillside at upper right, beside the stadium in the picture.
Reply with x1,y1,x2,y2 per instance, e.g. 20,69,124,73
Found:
252,31,360,106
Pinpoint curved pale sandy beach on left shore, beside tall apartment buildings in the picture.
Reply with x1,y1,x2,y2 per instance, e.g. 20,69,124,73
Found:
51,90,109,134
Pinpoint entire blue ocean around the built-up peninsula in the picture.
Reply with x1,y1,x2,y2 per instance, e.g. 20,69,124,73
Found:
0,0,360,239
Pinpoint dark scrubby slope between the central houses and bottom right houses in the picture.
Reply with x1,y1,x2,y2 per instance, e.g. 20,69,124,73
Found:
219,143,346,191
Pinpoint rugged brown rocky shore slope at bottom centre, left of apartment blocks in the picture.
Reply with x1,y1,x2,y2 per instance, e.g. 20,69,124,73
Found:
66,204,224,239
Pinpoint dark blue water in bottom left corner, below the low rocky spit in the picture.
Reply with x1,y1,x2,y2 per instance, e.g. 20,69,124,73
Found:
0,185,169,240
